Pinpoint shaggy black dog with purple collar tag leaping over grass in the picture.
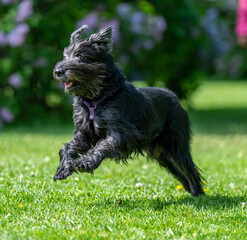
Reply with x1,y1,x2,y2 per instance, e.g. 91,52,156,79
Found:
53,25,204,196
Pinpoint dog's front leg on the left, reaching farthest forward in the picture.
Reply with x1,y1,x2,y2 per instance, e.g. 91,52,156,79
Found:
53,131,90,181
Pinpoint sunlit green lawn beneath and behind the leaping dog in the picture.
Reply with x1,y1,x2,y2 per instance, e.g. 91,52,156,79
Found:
0,82,247,239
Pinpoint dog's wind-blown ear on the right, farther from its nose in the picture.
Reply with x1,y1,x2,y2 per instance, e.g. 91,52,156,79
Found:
89,27,112,53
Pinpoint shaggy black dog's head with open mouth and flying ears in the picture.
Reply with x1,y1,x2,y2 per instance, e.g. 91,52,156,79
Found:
53,25,114,99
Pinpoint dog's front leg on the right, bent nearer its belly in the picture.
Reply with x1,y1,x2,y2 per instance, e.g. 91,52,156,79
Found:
74,136,120,173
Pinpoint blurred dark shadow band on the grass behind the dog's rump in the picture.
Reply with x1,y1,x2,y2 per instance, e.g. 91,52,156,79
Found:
189,108,247,135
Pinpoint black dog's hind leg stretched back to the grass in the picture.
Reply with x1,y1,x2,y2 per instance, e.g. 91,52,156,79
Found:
158,111,204,196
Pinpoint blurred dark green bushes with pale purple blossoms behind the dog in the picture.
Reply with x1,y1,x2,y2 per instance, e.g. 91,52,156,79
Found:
0,0,247,128
